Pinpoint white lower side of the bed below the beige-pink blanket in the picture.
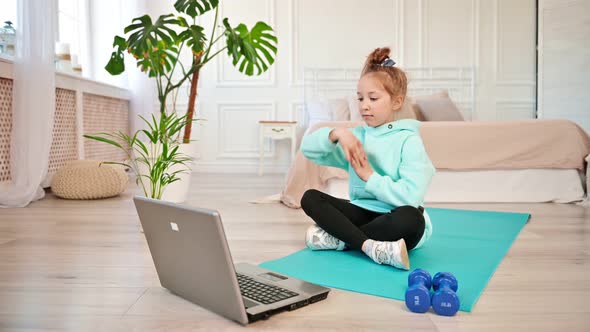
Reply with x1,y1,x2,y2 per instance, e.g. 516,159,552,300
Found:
326,169,585,203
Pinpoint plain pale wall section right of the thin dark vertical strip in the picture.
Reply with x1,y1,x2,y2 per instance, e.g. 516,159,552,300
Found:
539,0,590,132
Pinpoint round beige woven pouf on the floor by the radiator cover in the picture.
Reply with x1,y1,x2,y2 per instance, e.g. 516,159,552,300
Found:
51,160,129,199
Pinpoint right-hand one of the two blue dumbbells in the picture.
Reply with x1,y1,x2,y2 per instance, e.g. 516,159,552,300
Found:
431,272,461,316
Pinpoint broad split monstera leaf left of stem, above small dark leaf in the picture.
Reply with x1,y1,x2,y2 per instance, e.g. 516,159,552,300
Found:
125,14,179,57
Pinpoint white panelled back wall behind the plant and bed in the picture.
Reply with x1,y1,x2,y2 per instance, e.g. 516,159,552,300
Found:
140,0,536,174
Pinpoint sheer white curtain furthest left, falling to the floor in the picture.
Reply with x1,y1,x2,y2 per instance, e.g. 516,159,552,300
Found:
0,0,57,207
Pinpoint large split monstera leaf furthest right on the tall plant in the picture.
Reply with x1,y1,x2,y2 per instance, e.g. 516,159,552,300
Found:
223,18,277,76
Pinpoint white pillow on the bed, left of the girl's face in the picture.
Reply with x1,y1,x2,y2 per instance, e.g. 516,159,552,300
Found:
305,98,350,130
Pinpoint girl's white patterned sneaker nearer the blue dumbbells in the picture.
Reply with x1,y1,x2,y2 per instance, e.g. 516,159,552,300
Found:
363,239,410,270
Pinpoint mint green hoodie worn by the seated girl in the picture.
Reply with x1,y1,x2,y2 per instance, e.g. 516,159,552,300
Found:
301,119,435,248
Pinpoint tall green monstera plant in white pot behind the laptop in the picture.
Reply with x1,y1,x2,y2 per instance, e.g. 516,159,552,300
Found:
85,0,278,202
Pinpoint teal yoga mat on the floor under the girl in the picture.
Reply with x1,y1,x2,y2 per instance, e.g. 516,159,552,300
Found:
260,208,530,312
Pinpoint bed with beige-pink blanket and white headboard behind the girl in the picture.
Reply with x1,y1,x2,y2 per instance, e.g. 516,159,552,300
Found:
280,68,590,208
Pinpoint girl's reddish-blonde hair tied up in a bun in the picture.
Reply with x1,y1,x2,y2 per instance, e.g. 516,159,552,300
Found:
361,47,416,120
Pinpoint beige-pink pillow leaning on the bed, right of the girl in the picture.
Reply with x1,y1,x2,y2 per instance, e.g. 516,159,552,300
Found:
414,91,465,121
